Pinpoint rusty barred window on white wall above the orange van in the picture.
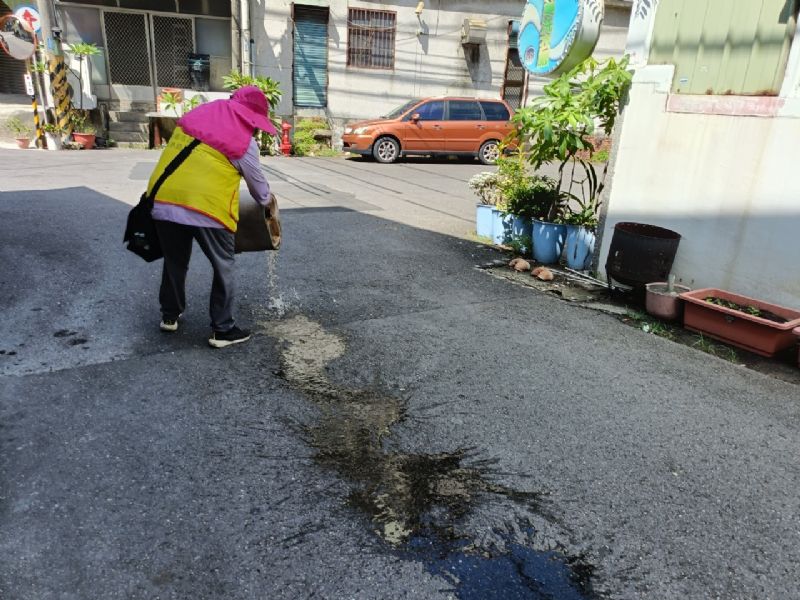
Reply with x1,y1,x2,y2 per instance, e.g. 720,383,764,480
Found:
347,8,397,69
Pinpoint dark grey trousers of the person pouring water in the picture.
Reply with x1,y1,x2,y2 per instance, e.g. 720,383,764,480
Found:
155,221,235,331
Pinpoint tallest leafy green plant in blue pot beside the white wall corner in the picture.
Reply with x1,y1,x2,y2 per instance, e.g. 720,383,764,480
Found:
512,57,632,264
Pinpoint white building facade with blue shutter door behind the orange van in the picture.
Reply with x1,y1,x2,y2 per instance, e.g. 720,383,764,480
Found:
251,0,630,123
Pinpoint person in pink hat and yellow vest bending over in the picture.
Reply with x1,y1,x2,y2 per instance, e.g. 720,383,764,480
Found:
148,86,277,348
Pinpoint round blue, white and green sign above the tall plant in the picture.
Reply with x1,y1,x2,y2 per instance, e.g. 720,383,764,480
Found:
519,0,605,76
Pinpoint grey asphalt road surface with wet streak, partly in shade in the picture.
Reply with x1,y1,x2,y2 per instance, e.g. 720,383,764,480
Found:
0,151,800,600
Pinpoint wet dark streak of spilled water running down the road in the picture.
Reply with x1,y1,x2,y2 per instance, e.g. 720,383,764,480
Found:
264,316,594,600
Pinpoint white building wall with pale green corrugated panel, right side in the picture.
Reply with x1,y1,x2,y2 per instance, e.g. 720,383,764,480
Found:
598,0,800,308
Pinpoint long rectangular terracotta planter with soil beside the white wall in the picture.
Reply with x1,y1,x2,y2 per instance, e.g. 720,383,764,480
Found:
681,288,800,357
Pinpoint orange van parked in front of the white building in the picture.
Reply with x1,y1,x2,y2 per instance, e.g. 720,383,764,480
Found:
342,97,513,165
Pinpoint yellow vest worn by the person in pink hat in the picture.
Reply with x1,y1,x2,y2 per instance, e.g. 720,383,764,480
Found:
147,127,241,233
